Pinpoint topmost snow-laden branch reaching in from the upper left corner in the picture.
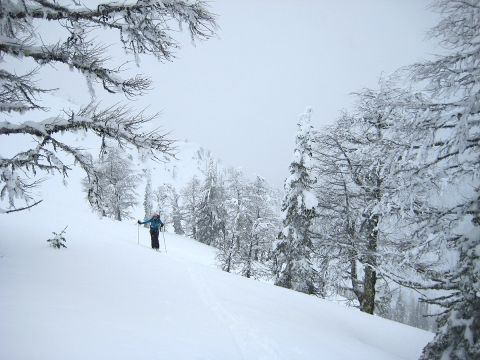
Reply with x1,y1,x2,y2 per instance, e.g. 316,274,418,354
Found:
0,0,216,60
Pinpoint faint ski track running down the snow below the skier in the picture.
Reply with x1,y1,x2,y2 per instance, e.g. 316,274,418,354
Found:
182,261,281,360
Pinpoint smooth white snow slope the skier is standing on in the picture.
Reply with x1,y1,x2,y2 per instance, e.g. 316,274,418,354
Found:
0,173,433,360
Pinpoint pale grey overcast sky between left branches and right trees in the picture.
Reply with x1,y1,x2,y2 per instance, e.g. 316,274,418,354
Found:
27,0,437,186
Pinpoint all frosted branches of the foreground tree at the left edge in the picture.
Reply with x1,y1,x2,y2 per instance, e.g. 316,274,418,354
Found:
0,0,215,212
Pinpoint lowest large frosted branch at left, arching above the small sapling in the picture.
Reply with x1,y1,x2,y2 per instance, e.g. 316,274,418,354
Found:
0,105,173,206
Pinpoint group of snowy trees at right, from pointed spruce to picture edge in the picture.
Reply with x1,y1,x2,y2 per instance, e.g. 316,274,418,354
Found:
274,0,480,359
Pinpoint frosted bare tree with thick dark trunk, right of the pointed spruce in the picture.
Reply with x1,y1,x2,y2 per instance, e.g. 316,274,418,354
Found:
315,79,428,314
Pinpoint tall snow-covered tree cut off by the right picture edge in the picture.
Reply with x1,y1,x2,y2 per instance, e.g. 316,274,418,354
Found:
400,0,480,359
